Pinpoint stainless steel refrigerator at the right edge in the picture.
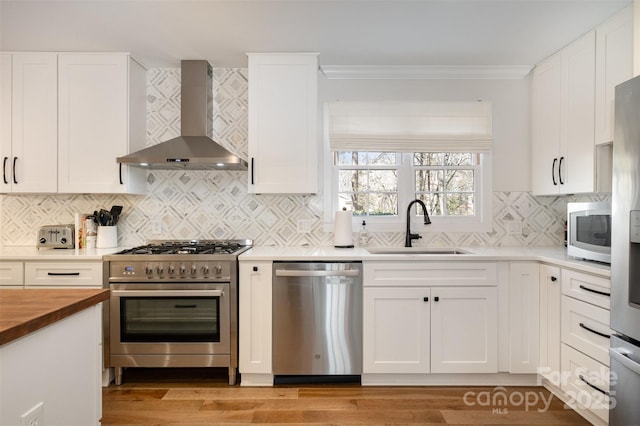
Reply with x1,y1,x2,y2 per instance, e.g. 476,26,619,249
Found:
609,77,640,426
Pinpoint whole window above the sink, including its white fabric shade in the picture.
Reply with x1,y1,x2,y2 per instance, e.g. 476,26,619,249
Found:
325,102,493,232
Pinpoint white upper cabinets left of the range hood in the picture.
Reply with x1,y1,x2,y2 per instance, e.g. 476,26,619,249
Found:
0,52,146,193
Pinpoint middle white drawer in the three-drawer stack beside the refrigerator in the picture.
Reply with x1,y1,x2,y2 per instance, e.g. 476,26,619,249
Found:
561,296,613,365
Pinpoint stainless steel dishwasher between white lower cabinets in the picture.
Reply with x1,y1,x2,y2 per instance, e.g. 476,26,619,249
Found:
273,262,362,376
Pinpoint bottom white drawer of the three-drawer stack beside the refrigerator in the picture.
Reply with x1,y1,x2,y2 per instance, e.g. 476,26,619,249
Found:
560,343,609,423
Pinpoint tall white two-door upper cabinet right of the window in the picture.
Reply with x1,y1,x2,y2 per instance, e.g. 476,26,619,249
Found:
532,31,596,195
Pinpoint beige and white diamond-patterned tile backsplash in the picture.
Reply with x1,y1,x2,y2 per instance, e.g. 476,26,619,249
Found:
0,68,610,247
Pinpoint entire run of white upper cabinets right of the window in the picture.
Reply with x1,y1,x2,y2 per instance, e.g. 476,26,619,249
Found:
532,7,633,195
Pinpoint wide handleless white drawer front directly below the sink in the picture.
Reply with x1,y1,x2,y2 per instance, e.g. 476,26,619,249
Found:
363,262,498,287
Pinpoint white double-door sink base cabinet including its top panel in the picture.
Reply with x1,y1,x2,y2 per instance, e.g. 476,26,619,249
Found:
363,262,498,374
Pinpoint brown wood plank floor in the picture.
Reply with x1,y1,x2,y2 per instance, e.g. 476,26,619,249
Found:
102,369,589,425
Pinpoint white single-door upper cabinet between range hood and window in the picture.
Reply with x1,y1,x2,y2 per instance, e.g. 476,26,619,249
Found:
248,53,319,194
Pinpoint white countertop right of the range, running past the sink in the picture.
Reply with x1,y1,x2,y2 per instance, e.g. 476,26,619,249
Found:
239,246,611,277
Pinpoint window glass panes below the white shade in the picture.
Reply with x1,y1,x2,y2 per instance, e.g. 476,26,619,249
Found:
333,151,483,231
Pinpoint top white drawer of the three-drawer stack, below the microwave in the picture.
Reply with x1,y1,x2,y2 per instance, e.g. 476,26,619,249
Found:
562,269,611,309
